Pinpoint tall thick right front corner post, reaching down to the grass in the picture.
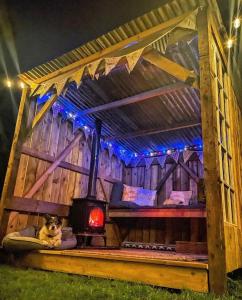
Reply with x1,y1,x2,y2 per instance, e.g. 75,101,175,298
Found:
197,7,227,294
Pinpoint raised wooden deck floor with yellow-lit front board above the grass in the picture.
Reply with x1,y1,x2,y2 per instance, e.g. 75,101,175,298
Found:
1,249,208,292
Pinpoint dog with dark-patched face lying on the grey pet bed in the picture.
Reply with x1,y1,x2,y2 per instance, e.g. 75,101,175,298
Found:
38,214,62,248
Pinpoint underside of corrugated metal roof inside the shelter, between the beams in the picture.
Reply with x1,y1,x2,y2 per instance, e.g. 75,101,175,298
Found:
60,38,202,153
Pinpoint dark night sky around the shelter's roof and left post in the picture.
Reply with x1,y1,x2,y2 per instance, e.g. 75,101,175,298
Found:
0,0,242,192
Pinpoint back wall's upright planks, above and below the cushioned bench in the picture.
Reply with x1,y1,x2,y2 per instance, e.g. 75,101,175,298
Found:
119,155,206,244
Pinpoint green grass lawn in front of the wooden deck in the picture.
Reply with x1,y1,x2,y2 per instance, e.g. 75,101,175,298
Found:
0,265,242,300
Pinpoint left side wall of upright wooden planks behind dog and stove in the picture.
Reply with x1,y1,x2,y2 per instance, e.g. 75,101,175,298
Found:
8,100,123,231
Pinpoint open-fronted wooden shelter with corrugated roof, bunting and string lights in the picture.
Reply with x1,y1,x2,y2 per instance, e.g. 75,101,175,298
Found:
0,0,242,294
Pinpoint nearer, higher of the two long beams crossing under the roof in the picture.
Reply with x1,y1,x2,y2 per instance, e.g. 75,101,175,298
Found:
79,82,189,116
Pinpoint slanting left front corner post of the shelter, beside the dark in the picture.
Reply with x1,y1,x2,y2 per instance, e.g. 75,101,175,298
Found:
0,87,29,242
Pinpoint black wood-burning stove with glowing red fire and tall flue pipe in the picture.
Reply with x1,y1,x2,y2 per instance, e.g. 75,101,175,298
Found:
69,119,107,246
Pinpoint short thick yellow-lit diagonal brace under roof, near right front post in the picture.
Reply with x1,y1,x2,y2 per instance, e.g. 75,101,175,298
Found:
143,50,198,88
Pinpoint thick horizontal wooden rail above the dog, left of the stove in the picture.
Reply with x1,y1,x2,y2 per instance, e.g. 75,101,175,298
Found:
6,197,70,217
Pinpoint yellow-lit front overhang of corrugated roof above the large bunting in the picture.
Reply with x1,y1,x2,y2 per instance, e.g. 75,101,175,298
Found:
22,0,199,80
